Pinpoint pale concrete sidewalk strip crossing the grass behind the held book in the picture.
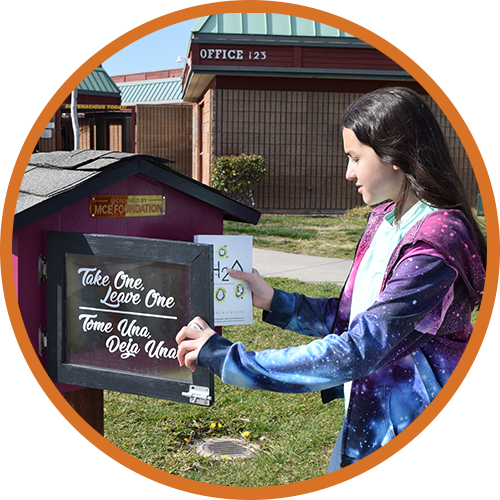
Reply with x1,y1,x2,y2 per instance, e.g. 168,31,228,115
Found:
253,248,352,285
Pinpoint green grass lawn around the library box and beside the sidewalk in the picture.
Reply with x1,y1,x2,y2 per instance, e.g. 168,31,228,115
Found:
11,212,488,487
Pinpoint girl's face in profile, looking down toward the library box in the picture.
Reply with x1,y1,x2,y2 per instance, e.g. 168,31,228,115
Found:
342,127,404,205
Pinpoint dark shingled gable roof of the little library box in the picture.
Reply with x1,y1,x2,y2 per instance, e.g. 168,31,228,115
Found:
14,150,260,231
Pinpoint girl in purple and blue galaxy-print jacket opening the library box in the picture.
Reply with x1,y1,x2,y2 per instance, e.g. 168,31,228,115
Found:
177,88,486,486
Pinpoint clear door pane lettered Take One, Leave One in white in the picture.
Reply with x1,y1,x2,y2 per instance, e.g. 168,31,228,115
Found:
66,254,191,380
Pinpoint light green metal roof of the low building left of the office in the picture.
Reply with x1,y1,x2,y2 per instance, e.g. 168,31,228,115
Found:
116,78,182,106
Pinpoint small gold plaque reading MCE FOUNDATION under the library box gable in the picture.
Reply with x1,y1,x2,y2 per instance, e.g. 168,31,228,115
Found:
89,194,165,217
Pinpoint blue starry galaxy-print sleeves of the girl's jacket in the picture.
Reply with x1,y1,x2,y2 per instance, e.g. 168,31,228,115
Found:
198,255,457,393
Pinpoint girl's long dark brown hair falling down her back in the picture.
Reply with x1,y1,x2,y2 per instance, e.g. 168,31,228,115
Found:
343,87,486,263
